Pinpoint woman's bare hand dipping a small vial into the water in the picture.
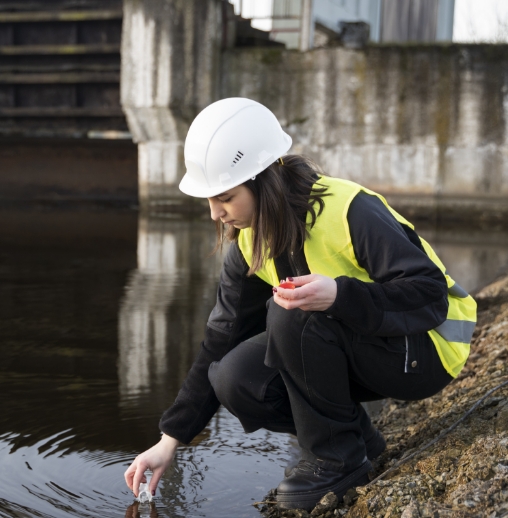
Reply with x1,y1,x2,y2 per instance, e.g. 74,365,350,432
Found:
124,434,180,498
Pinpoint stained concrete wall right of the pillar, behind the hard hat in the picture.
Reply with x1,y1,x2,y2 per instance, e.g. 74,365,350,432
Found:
221,45,508,217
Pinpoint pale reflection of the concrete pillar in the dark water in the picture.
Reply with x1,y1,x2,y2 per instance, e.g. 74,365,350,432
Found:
118,216,221,415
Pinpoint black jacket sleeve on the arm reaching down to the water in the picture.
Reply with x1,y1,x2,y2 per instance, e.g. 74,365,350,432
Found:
159,243,272,444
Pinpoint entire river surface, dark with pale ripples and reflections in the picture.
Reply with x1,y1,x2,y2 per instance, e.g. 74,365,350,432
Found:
0,209,508,518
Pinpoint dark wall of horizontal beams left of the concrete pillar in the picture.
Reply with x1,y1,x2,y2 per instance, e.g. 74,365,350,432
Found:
0,0,128,137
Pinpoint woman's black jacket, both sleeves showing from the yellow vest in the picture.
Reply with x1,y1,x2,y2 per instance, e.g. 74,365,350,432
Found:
159,192,448,443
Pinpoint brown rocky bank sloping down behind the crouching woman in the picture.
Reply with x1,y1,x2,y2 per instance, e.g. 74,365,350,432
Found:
260,273,508,518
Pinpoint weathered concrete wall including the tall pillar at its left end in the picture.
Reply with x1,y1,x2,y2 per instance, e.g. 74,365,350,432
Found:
121,0,508,218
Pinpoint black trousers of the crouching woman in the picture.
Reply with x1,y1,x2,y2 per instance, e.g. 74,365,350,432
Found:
208,299,453,471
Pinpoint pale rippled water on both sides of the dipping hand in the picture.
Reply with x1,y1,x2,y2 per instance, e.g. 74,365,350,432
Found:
0,409,298,518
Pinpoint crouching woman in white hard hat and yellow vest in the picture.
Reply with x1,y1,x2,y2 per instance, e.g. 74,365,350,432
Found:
125,98,476,509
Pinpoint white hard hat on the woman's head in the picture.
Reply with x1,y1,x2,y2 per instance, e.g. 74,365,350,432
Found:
180,97,292,198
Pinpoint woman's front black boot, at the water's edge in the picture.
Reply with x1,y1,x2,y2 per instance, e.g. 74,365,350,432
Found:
277,459,372,511
